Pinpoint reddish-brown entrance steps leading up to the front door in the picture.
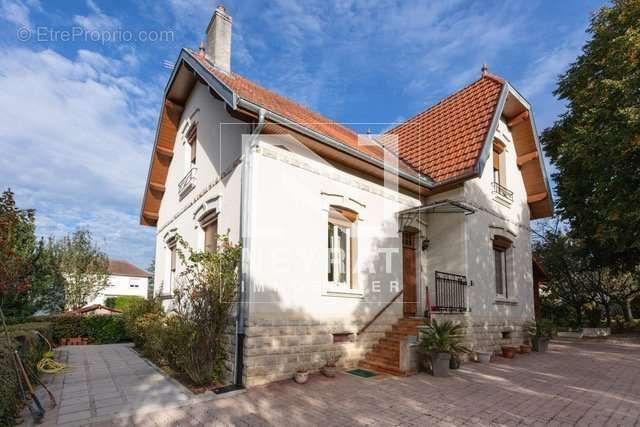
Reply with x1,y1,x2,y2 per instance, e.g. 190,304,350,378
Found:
358,317,427,376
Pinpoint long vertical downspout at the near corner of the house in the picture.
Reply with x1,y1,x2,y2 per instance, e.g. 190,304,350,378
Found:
233,108,265,390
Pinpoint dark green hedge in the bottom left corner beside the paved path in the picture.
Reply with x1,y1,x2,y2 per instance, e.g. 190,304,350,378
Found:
0,322,52,426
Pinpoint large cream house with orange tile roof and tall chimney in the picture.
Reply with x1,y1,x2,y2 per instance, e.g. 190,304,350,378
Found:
141,7,552,385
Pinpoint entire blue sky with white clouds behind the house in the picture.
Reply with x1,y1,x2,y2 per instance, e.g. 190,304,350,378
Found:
0,0,605,267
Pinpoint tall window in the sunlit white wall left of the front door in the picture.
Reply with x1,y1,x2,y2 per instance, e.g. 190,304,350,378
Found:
327,206,358,289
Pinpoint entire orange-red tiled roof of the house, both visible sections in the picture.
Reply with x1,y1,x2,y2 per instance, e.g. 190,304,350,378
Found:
193,53,504,183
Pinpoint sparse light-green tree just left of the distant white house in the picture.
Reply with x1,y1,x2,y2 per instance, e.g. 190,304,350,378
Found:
56,230,109,309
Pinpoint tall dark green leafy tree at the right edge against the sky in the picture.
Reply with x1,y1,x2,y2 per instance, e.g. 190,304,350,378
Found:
541,0,640,271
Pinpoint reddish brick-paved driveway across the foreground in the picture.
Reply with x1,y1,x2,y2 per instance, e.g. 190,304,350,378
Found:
36,340,640,427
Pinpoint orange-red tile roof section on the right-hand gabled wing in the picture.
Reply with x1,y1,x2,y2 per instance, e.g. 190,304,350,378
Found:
388,74,504,182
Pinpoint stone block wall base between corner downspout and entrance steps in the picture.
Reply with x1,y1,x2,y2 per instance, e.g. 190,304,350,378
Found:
244,303,402,386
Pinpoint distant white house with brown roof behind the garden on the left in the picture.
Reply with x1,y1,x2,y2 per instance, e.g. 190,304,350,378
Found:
85,259,150,308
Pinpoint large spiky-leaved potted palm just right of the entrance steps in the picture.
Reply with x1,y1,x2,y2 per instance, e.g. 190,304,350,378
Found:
419,320,469,377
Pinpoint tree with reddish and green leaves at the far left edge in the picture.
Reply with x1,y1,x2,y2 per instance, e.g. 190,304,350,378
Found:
0,189,36,316
